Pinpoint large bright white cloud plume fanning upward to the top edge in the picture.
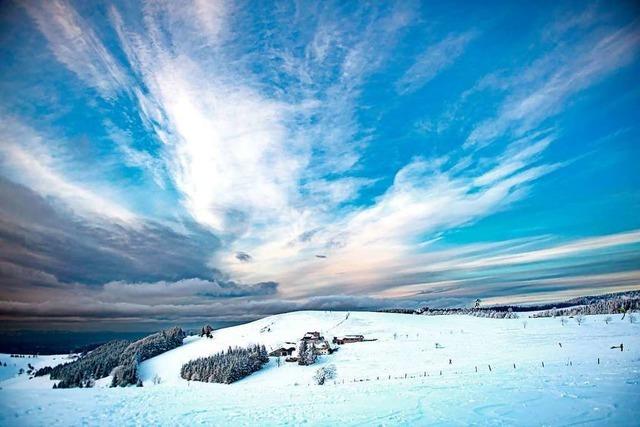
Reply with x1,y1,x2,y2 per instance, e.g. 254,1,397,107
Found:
111,0,418,242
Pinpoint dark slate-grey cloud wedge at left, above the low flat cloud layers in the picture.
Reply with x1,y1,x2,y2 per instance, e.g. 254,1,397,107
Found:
0,178,220,288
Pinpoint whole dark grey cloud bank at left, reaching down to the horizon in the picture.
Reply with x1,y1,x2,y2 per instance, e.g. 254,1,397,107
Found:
0,177,404,329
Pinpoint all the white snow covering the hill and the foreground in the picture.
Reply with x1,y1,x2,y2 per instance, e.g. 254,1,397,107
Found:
0,312,640,425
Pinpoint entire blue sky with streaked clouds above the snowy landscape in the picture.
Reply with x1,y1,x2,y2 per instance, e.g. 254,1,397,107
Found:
0,0,640,329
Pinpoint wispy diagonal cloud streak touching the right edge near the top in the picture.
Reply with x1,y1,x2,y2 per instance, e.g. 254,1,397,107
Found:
465,23,640,147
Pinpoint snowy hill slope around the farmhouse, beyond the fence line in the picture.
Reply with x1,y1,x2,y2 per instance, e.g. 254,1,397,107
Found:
140,312,640,386
